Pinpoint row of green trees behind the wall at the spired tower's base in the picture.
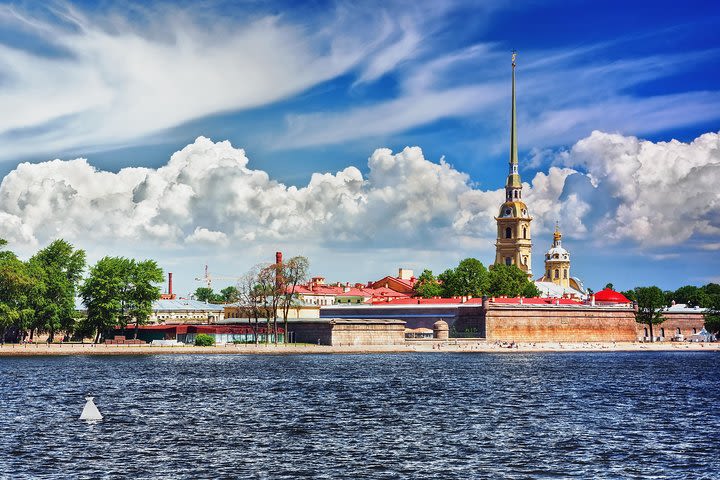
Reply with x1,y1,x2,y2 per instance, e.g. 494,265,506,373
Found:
414,258,540,298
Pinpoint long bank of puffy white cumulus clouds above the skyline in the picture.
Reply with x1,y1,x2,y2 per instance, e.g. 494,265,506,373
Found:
0,132,720,264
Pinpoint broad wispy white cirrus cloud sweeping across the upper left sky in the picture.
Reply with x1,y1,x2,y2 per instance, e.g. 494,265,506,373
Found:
0,3,462,163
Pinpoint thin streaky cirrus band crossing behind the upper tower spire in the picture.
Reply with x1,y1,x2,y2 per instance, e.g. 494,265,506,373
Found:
276,40,720,149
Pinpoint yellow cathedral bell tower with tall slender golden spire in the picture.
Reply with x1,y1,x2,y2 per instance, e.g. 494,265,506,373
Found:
495,52,532,277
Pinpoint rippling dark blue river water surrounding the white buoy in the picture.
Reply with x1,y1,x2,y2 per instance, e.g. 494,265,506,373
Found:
0,352,720,479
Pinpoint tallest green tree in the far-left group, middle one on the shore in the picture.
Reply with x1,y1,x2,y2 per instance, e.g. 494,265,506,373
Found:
28,239,85,341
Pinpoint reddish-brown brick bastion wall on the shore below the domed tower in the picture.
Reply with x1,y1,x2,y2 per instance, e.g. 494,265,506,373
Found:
485,306,638,342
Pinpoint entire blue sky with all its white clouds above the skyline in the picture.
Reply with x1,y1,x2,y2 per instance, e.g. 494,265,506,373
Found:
0,0,720,295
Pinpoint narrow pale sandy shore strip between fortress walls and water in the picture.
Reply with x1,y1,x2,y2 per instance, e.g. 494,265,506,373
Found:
0,340,720,356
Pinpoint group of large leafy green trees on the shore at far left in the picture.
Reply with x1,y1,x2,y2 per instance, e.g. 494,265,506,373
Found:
0,239,163,342
